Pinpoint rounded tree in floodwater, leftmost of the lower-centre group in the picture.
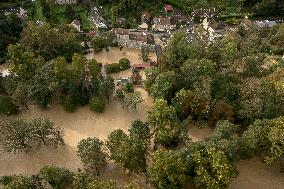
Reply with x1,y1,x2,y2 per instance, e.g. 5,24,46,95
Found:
77,138,106,176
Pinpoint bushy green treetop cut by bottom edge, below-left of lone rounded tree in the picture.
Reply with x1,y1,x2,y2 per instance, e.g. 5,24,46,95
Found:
39,166,74,189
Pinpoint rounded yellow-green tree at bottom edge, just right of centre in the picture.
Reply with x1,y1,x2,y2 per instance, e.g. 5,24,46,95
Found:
148,150,191,189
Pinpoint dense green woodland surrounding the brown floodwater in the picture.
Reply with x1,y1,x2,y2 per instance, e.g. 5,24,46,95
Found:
0,0,284,189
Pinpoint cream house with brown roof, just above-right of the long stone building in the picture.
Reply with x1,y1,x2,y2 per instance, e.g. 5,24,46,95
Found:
152,17,176,31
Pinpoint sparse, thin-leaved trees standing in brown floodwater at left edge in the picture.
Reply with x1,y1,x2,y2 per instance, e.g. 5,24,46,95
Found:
0,118,64,152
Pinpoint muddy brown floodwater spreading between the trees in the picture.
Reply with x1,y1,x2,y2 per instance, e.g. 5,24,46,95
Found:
0,48,284,189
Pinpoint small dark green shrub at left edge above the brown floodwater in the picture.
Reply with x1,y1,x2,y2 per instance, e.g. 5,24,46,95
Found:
0,96,18,116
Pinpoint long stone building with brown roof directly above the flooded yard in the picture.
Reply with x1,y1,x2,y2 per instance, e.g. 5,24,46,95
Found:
112,28,155,51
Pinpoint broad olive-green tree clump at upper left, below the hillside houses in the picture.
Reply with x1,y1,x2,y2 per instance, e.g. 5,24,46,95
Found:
20,22,82,61
